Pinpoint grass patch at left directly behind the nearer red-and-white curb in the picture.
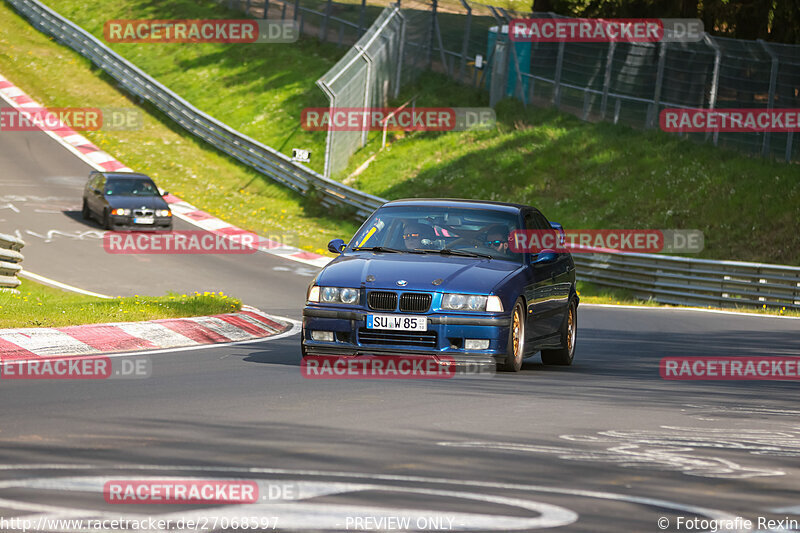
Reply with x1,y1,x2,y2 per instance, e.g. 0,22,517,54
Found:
0,279,242,329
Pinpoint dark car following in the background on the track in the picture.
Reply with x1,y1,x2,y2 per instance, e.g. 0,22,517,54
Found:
81,171,172,231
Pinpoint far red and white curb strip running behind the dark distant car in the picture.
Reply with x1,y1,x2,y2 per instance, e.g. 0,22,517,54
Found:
0,71,331,268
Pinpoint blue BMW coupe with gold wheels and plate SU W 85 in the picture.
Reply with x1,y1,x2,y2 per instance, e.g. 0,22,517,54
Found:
302,199,579,372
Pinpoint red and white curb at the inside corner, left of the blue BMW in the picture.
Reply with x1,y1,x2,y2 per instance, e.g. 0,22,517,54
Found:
0,306,297,362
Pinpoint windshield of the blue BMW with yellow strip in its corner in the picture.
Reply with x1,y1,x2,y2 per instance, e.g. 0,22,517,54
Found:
348,206,522,262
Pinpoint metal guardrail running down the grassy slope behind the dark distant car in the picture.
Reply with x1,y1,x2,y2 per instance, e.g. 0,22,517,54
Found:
6,0,386,217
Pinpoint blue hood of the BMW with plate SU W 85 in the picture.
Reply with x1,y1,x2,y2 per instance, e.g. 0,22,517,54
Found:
316,252,522,294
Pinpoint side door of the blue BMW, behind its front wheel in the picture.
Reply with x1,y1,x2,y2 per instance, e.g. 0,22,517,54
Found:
523,210,553,344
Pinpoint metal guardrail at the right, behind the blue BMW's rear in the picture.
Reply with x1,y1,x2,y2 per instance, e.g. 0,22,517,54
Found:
573,253,800,309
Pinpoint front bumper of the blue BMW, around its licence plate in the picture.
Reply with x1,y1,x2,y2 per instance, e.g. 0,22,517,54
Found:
302,306,511,365
